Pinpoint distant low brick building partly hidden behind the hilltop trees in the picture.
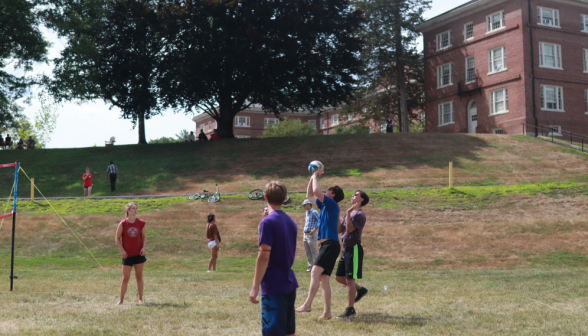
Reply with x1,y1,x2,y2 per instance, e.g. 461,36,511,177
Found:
192,105,386,138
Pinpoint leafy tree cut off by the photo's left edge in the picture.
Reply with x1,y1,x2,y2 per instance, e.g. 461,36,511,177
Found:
0,0,48,128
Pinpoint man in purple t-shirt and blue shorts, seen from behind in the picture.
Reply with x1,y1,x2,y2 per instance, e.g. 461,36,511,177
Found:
249,181,298,336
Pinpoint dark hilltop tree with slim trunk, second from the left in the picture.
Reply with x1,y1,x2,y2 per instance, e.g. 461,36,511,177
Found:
48,0,164,144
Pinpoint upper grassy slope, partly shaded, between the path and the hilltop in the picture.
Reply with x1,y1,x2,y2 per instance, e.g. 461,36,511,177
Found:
0,133,588,197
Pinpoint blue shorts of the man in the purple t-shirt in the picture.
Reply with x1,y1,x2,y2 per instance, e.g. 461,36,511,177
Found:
261,289,296,336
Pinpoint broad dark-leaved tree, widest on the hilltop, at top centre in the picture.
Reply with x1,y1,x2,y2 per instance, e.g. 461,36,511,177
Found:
158,0,363,138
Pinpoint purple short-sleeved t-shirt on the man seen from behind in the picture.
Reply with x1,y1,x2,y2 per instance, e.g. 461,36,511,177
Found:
259,210,298,295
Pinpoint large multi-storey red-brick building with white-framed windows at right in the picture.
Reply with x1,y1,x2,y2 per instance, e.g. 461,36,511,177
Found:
417,0,588,136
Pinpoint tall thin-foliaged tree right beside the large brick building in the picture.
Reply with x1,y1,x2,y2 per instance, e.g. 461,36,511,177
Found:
345,0,431,132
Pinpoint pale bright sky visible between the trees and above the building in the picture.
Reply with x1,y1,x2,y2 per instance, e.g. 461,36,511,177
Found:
12,0,469,148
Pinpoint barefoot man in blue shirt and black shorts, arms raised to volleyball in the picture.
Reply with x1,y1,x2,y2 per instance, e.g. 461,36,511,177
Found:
296,168,345,320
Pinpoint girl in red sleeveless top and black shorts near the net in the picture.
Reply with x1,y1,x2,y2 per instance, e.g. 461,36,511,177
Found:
116,202,147,305
